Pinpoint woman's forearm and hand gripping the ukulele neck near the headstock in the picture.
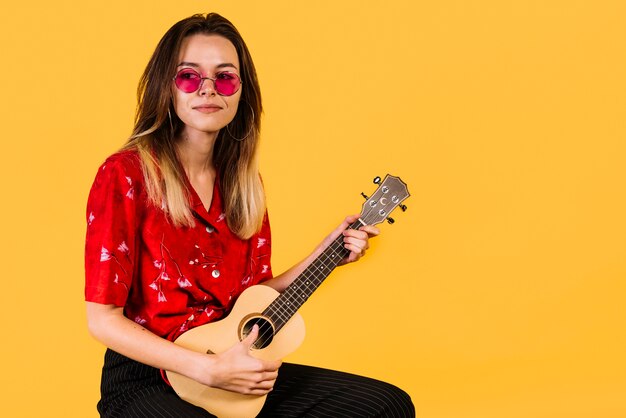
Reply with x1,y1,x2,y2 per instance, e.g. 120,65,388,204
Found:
263,215,380,292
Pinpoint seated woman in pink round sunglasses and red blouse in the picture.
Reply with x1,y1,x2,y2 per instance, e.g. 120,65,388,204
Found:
85,14,414,417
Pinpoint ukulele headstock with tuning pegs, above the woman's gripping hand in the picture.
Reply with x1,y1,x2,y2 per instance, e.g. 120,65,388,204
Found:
361,174,411,225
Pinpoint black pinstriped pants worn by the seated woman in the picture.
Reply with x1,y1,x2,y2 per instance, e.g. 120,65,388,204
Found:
98,350,415,418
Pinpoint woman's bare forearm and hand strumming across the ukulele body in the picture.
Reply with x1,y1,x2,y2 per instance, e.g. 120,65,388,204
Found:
87,302,281,395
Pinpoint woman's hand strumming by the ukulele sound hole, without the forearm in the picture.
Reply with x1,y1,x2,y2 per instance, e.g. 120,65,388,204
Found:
194,325,282,395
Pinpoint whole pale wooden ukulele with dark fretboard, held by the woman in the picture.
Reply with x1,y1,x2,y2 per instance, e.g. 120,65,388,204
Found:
166,175,410,418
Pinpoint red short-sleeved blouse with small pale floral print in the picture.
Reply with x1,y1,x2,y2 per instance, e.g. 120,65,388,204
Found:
85,151,272,340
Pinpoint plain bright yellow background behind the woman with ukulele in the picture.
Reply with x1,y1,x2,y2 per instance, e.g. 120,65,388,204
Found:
0,0,626,418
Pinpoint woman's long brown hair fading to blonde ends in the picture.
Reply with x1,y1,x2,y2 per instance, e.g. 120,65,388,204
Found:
122,13,265,239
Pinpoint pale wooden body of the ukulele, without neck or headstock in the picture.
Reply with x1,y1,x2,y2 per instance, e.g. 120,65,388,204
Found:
167,285,304,418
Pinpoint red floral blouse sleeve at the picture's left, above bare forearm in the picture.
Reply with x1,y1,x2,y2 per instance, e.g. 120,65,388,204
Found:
85,157,138,306
